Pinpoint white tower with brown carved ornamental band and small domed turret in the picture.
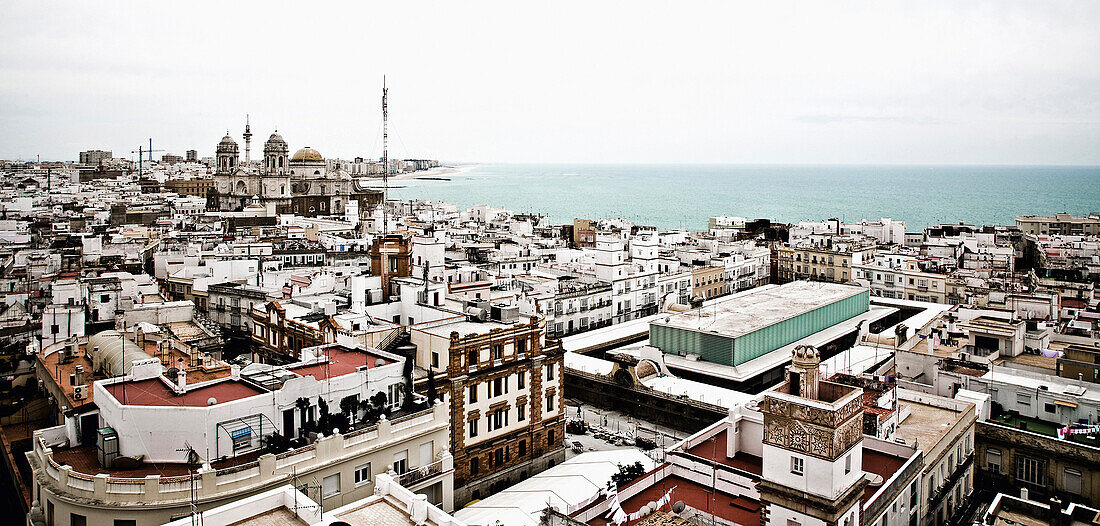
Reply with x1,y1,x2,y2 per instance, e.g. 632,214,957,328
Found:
757,346,867,526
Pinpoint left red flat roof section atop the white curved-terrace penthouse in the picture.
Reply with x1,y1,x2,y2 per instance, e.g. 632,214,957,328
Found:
106,377,264,407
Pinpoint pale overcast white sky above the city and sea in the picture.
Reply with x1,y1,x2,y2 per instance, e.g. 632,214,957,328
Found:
0,0,1100,164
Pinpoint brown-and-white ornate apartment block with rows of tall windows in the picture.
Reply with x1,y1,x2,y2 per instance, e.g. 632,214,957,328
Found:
408,314,565,504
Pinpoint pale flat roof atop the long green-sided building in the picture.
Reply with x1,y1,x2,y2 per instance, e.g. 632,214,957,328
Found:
652,282,867,338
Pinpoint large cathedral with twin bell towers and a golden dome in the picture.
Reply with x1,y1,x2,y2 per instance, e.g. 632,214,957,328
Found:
207,124,382,217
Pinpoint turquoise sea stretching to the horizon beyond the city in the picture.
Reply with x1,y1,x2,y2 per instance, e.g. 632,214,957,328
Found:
391,164,1100,231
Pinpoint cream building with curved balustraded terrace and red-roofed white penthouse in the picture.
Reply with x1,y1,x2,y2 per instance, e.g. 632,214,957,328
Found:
26,346,453,526
